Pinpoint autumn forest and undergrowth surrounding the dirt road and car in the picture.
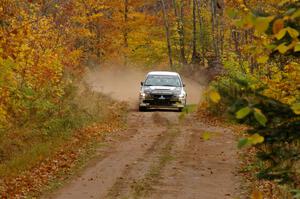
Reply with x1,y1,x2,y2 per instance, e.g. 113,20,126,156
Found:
0,0,300,199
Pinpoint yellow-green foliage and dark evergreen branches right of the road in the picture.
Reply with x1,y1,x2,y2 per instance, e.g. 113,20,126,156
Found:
206,1,300,197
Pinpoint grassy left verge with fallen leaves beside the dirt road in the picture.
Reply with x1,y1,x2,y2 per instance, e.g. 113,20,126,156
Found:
0,86,127,197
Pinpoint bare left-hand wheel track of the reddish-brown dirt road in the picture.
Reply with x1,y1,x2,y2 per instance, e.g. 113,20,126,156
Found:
47,112,176,199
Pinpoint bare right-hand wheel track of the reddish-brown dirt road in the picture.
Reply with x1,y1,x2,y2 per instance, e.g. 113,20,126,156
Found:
147,117,239,199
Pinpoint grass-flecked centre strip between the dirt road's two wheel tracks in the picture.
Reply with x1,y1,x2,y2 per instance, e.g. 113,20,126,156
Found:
106,112,178,199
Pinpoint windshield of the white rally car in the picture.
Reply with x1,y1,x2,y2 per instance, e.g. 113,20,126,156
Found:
145,75,181,87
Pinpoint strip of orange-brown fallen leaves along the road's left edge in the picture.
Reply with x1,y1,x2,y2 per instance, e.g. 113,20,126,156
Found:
0,103,123,199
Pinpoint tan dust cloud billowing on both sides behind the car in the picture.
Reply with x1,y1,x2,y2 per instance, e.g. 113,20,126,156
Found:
85,67,203,108
